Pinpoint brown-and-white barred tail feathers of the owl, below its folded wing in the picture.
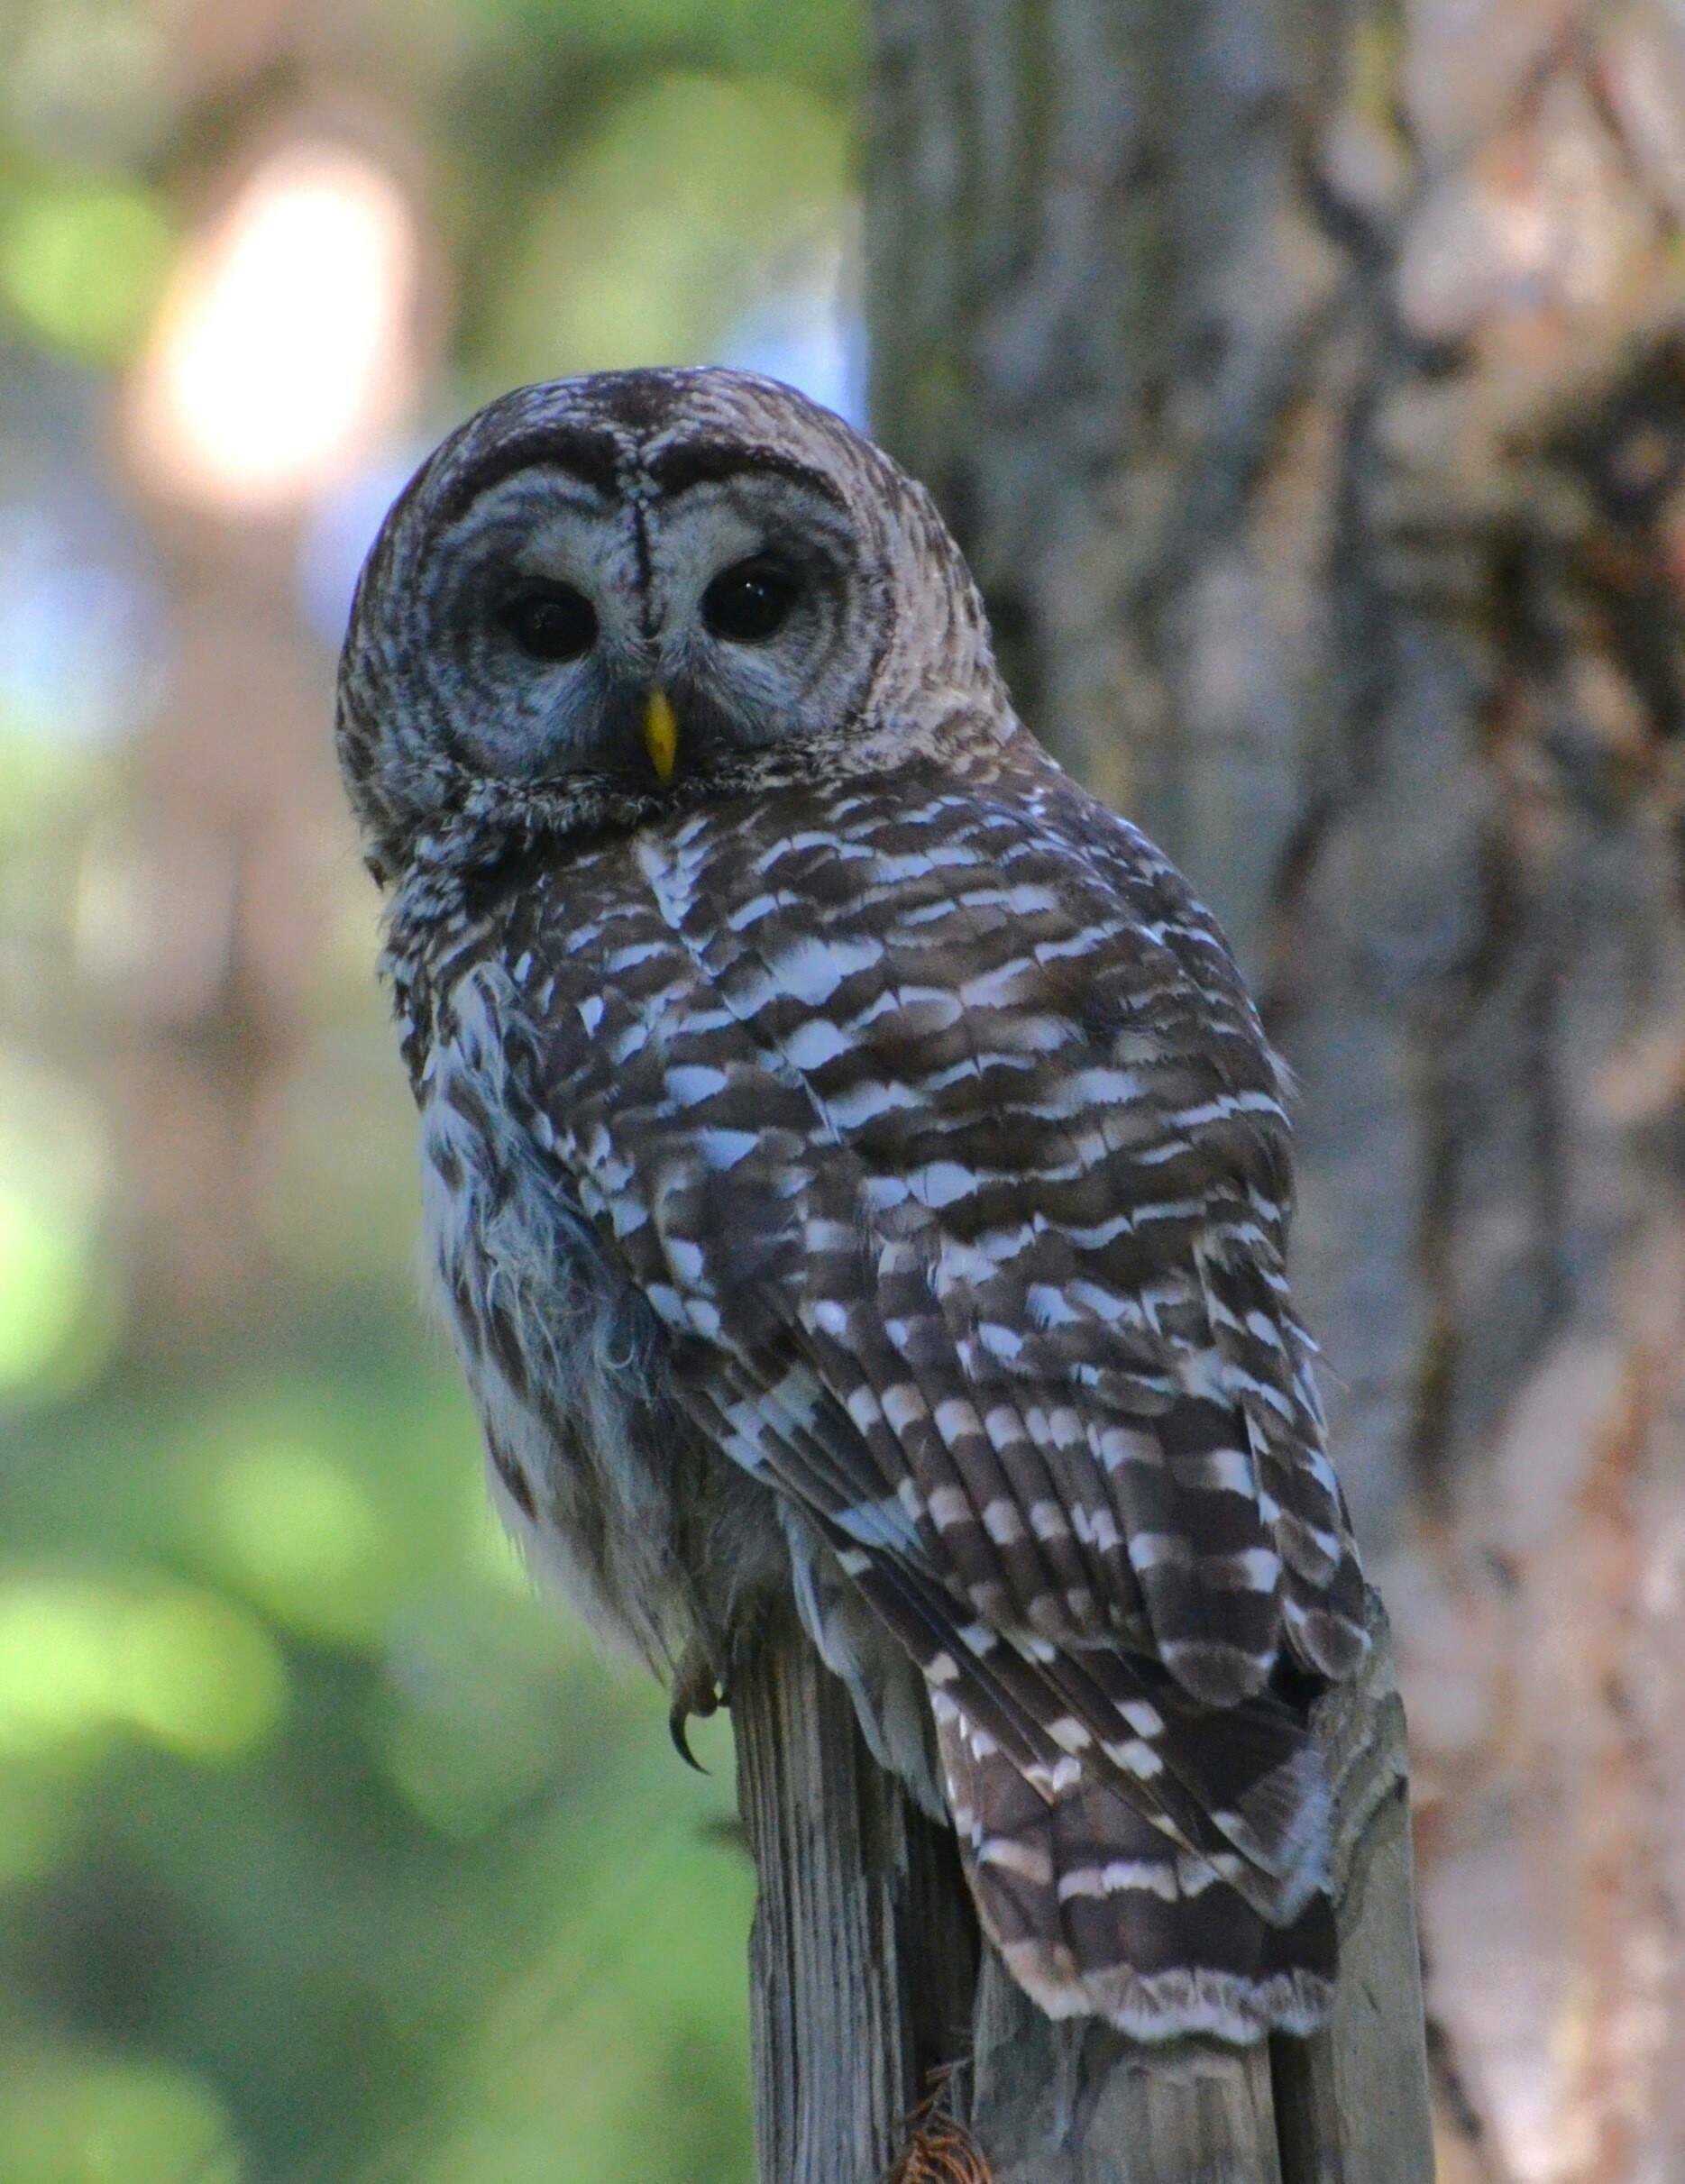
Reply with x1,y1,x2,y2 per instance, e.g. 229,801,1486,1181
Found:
821,1553,1335,2042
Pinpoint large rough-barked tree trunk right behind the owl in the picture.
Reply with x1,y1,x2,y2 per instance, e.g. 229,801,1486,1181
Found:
867,0,1685,2184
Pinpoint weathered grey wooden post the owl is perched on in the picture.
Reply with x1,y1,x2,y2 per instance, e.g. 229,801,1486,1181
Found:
732,1599,1433,2184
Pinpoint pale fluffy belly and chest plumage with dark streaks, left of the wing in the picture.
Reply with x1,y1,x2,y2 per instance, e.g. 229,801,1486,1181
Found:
393,873,783,1671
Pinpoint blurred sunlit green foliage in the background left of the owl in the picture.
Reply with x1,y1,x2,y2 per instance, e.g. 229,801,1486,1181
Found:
0,0,861,2184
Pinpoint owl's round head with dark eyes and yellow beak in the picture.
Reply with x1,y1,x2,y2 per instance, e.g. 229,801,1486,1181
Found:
339,369,1008,878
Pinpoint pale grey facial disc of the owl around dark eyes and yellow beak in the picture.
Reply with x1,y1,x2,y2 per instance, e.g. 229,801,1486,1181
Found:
442,456,883,789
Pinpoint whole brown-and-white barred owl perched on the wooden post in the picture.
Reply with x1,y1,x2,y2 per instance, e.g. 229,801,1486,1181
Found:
339,371,1364,2040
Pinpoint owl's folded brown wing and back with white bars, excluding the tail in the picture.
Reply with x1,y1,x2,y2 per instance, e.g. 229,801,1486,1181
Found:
527,794,1364,1705
